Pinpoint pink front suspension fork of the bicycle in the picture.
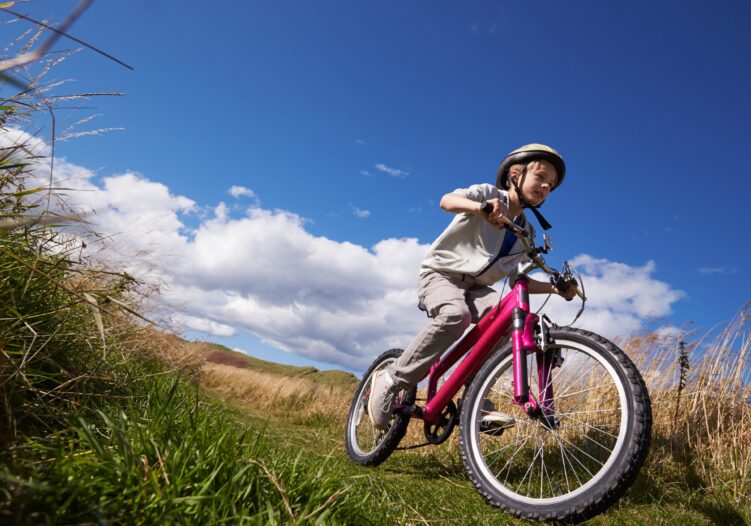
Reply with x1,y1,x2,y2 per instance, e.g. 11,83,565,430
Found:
511,276,560,428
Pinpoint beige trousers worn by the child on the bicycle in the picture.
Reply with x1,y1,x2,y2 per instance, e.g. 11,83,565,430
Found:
389,271,500,389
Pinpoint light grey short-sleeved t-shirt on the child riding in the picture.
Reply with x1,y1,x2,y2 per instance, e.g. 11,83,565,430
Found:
420,184,535,285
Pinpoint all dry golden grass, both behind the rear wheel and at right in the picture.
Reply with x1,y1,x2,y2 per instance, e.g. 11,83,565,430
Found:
192,304,751,504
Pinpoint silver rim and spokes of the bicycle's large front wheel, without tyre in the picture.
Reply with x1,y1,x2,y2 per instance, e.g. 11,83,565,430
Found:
470,338,628,505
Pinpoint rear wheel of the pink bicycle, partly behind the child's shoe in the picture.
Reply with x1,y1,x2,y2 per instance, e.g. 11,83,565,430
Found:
345,349,415,466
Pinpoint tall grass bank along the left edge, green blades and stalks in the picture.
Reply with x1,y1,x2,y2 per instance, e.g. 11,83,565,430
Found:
0,10,369,524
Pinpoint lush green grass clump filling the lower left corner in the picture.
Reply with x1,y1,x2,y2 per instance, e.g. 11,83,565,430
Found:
0,368,374,524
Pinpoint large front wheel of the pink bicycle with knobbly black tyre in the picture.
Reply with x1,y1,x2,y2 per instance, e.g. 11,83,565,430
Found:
460,329,652,520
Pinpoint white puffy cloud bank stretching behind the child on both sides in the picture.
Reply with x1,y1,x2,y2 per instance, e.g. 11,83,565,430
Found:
0,132,683,370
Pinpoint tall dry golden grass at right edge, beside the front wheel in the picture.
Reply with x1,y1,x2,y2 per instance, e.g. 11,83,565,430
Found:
624,303,751,504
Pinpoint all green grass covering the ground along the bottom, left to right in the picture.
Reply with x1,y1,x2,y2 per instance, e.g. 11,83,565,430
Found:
0,356,751,525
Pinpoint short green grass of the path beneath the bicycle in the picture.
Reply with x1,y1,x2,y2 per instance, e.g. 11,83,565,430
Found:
232,400,751,526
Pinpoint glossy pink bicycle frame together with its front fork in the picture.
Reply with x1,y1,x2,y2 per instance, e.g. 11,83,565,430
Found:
420,274,555,424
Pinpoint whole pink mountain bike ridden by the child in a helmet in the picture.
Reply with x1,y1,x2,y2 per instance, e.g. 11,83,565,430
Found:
346,224,652,520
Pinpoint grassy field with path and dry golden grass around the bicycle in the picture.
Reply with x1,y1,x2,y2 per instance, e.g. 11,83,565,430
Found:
184,324,751,524
